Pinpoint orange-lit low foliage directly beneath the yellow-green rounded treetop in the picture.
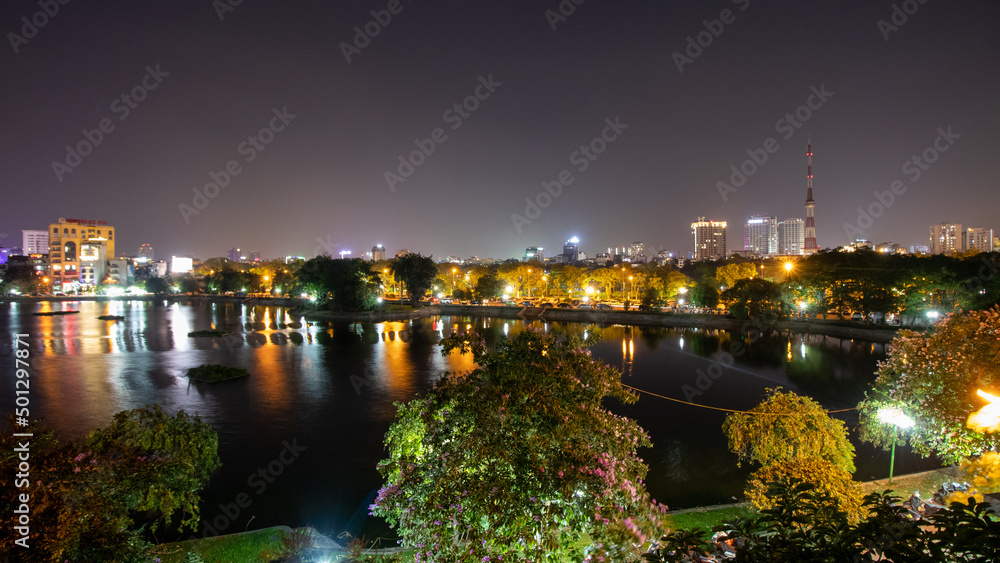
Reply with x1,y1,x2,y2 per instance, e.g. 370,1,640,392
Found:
746,457,864,522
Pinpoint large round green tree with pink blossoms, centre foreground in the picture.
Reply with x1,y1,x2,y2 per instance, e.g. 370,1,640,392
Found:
372,330,664,562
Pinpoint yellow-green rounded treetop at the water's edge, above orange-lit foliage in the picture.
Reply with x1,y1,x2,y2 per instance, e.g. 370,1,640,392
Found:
722,388,854,473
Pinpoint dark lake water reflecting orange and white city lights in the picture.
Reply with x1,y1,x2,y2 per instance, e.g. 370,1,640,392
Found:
0,301,933,539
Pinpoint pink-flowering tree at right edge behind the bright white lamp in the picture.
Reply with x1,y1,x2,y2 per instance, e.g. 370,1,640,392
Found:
858,307,1000,463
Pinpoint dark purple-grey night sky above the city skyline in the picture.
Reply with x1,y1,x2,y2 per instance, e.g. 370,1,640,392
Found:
0,0,1000,258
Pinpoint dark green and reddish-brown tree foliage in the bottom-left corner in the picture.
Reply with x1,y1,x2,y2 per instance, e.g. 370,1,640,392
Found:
0,406,220,562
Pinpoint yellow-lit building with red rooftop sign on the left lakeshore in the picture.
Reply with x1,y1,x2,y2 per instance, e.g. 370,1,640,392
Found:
48,219,116,291
